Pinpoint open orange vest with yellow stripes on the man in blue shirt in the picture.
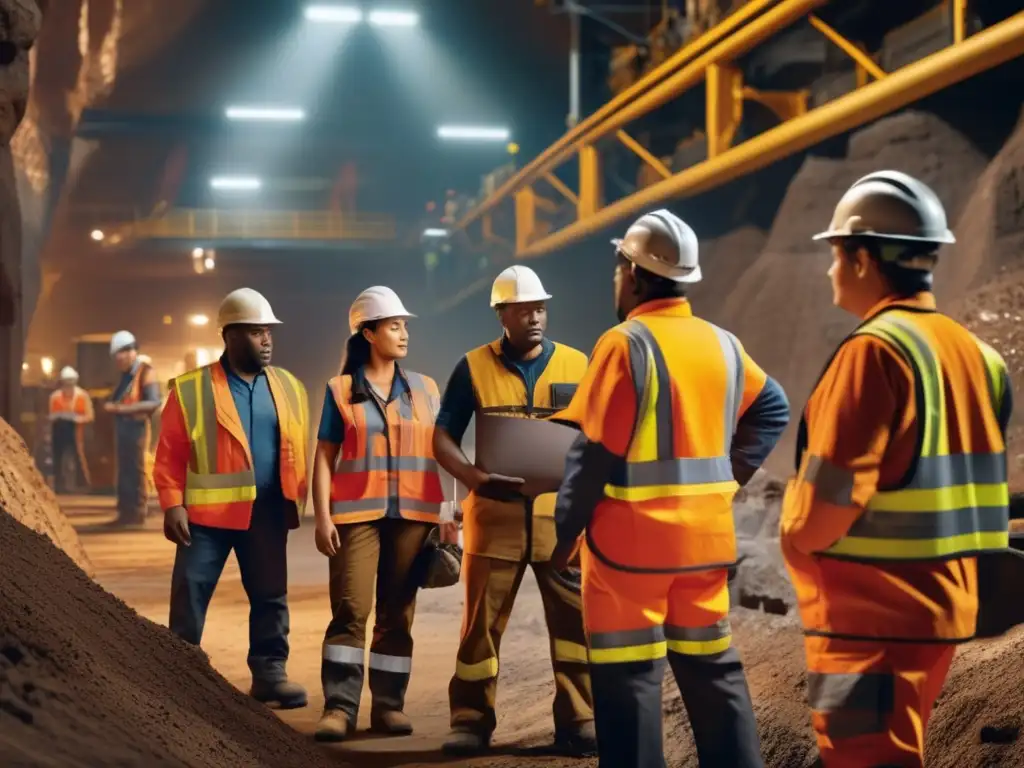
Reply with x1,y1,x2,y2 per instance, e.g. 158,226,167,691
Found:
173,360,308,530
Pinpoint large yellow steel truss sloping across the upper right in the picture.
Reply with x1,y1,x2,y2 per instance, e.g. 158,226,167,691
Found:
455,0,1024,258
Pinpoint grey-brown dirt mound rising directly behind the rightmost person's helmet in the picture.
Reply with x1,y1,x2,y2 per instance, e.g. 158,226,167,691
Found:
723,112,986,474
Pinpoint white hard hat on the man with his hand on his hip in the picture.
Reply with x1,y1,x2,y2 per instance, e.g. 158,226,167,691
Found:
611,208,702,283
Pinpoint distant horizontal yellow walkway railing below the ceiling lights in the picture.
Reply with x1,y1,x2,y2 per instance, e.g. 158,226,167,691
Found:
109,208,396,245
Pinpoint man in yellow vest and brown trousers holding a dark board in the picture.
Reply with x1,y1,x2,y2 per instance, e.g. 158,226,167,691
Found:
434,265,596,756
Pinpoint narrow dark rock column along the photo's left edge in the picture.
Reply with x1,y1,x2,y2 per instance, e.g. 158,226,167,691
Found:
0,0,42,420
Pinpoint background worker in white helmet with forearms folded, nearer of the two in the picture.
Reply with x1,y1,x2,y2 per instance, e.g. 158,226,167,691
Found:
103,331,161,525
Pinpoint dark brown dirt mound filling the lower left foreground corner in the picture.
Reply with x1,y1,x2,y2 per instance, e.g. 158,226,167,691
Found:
0,513,338,768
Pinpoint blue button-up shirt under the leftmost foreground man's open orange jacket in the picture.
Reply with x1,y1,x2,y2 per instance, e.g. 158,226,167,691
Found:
220,356,285,511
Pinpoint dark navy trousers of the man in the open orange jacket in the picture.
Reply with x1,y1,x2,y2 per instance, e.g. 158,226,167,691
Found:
170,505,289,682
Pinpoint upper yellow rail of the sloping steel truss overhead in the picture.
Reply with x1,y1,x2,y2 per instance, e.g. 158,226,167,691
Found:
455,0,779,229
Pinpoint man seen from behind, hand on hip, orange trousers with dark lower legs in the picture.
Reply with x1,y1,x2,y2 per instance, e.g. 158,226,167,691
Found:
552,210,790,768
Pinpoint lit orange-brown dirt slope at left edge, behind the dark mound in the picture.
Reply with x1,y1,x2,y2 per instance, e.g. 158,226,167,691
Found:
0,419,93,575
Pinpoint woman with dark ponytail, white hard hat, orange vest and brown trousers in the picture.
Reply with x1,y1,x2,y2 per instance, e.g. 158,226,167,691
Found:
313,286,458,741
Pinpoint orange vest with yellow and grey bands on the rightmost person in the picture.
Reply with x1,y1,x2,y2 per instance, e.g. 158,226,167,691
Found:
783,304,1009,642
